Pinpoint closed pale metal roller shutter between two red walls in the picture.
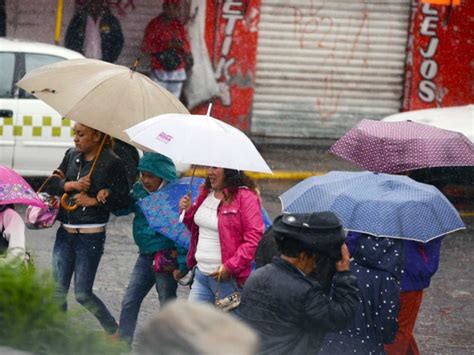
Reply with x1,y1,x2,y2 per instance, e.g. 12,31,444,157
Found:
251,0,410,138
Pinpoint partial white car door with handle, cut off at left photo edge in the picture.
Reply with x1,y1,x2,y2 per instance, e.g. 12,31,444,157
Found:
0,52,18,167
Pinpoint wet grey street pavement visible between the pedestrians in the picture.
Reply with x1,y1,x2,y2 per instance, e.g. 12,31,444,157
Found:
27,147,474,354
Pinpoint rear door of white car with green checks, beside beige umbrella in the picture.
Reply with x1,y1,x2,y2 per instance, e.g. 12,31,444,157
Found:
13,53,73,176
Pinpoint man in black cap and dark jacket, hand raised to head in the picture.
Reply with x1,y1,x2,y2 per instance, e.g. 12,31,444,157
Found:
240,212,359,354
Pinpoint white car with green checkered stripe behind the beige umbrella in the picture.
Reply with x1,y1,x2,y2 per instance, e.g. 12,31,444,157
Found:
0,38,84,176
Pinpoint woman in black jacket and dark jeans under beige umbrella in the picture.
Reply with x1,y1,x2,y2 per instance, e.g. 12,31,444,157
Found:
45,123,128,334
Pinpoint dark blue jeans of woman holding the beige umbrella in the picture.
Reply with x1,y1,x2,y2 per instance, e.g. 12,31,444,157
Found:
53,227,117,334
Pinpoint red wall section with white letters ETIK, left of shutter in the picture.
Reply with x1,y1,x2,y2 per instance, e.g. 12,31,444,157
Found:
193,0,260,131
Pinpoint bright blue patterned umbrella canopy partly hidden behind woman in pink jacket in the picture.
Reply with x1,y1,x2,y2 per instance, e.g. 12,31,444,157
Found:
138,177,271,249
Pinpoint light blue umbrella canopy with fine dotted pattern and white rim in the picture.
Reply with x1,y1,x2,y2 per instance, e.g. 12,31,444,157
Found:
280,171,465,242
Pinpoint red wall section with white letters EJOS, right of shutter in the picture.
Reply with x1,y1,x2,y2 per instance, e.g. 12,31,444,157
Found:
403,0,474,111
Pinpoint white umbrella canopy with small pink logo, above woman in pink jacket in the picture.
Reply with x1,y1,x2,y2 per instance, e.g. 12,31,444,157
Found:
126,114,272,173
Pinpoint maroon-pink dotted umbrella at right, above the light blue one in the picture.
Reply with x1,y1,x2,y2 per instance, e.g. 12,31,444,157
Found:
329,120,474,173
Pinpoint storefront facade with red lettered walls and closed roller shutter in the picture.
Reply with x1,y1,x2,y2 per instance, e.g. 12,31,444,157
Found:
2,0,474,138
